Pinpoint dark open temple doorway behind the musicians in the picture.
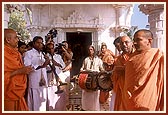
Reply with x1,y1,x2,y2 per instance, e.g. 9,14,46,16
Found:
66,32,92,77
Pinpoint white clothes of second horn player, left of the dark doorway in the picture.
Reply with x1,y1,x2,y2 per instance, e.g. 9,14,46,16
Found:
47,54,66,111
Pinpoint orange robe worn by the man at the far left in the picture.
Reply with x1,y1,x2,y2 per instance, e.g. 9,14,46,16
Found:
4,45,28,111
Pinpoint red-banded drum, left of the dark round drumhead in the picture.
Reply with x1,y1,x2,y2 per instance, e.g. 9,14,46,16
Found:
78,72,98,90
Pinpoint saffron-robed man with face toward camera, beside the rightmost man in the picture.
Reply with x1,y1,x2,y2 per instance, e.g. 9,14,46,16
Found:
111,36,134,111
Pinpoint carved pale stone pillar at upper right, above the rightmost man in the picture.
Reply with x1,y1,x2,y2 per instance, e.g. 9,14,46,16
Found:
139,4,166,50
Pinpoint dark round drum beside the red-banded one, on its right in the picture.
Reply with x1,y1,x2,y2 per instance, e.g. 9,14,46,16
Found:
98,72,113,91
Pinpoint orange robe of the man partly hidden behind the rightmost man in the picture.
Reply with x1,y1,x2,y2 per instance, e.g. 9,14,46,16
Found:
112,54,129,111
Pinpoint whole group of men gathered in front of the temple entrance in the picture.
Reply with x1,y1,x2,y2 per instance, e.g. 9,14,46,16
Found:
4,29,165,111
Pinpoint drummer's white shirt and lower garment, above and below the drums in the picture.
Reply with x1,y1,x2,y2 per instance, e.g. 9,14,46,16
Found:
81,57,104,111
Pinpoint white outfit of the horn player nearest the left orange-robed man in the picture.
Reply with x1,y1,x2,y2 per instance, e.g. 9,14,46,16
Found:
24,48,48,111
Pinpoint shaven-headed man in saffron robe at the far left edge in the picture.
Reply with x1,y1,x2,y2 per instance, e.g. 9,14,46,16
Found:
4,29,32,111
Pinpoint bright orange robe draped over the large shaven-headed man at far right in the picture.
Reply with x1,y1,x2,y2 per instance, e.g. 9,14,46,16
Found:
122,48,164,111
